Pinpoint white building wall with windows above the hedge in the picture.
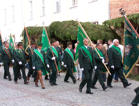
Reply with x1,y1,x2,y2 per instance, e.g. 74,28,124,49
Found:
0,0,109,41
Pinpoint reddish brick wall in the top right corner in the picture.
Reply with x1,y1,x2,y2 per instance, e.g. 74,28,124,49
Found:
110,0,139,19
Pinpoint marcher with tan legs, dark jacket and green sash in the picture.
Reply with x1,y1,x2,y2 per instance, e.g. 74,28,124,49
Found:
32,44,46,89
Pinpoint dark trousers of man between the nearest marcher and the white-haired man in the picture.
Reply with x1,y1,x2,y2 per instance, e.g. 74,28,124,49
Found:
92,69,105,88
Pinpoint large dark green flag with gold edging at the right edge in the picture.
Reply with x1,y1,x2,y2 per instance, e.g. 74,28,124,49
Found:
124,19,139,77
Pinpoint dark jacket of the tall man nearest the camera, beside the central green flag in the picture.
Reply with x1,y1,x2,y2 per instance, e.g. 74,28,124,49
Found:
79,47,94,70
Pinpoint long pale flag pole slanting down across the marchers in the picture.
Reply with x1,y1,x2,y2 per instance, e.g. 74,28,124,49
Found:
78,22,111,75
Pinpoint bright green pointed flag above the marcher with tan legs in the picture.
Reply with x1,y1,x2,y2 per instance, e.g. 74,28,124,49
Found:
41,28,50,51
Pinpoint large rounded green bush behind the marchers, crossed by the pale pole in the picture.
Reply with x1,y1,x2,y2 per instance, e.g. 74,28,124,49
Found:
49,21,117,41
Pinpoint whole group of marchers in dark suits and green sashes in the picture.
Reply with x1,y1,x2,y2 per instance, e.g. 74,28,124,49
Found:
0,39,131,94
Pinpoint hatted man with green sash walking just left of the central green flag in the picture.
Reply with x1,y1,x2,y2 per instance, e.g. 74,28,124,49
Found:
62,42,76,84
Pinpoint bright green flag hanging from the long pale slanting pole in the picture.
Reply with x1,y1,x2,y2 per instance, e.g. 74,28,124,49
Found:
75,26,86,61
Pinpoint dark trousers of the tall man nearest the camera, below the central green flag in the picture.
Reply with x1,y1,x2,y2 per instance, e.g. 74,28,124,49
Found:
79,69,92,91
